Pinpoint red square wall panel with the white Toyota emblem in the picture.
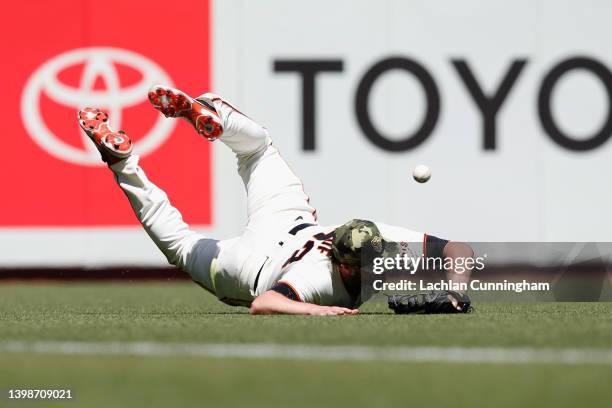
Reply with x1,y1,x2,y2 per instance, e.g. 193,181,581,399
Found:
0,0,213,228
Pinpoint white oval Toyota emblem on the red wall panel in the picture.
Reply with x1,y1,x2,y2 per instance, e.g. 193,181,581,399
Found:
21,47,176,166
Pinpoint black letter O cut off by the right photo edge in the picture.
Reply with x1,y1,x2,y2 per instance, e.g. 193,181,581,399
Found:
538,58,612,151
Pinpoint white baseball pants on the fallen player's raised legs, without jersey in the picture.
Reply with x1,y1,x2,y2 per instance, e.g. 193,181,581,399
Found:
111,100,316,296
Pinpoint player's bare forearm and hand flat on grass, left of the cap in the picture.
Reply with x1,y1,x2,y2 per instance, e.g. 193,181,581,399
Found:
250,283,359,316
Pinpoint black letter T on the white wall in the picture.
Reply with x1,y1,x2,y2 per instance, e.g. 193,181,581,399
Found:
274,60,343,150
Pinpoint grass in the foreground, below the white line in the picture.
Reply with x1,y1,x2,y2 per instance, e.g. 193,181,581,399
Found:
0,355,612,408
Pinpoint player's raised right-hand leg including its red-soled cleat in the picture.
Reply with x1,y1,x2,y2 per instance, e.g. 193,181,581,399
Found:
149,86,316,230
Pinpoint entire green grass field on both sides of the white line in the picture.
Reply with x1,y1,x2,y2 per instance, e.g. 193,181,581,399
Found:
0,282,612,407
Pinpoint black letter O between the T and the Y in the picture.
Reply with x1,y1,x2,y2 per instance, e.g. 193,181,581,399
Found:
355,57,440,152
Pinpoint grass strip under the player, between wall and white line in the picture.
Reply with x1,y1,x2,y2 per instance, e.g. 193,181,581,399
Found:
0,283,612,348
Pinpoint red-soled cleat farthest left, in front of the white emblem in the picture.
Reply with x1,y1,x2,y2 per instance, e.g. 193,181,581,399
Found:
78,108,132,165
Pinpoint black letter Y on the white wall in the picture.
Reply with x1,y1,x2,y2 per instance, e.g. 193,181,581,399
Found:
451,60,527,150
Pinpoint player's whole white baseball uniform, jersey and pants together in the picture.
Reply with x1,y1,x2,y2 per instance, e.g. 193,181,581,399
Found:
111,95,425,307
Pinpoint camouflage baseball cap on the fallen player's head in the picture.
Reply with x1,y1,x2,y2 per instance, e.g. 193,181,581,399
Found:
332,219,385,266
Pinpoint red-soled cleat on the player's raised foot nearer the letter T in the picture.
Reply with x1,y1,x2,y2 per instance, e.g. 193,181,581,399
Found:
149,85,223,141
